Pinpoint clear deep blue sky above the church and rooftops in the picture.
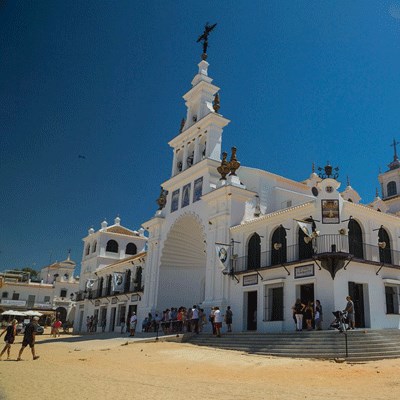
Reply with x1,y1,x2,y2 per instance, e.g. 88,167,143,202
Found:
0,0,400,270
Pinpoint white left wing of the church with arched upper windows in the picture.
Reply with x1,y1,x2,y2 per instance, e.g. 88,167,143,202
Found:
74,217,147,332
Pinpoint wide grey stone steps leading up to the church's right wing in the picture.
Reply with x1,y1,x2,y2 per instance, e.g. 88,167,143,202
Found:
183,329,400,362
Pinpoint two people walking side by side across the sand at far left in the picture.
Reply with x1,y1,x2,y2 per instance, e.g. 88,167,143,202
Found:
0,317,39,361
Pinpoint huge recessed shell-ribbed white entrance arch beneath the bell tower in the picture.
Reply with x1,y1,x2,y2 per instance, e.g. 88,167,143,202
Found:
157,214,207,311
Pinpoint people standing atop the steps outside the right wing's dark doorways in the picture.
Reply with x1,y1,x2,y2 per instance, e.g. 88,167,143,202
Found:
292,296,355,331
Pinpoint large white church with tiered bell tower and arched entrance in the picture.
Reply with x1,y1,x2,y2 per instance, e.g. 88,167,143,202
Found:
75,42,400,332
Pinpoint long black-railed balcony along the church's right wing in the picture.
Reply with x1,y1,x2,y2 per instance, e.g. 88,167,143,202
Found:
233,235,400,276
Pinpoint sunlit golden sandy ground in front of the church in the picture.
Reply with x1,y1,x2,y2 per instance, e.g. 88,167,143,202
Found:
0,335,400,400
